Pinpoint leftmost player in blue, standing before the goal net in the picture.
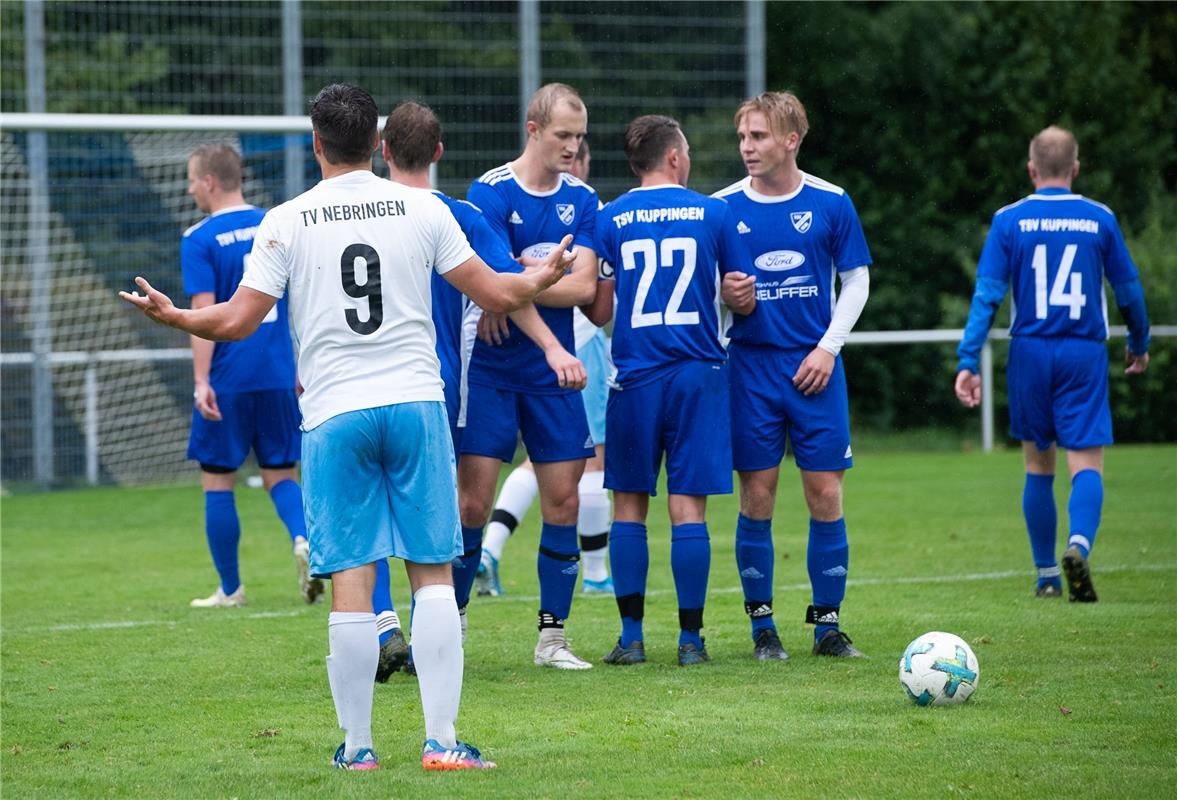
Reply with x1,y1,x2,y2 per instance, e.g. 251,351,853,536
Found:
180,144,322,608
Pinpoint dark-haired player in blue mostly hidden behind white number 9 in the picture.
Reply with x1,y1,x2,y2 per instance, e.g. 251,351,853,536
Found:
372,100,584,682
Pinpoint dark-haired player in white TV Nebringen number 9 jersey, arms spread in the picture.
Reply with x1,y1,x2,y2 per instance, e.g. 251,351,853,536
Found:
120,84,571,769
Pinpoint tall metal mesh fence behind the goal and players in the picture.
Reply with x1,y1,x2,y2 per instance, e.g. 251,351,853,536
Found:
0,0,764,485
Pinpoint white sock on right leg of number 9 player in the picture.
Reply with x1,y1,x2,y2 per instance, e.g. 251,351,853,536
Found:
411,584,465,747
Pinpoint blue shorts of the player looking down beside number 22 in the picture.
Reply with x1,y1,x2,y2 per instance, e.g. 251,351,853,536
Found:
461,384,593,464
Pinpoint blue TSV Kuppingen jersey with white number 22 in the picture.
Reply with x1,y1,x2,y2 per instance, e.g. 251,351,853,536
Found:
596,186,752,387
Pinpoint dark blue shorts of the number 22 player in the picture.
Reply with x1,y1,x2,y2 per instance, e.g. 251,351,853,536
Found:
605,361,732,496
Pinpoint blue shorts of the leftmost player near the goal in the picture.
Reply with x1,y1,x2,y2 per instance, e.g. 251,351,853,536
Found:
188,389,301,469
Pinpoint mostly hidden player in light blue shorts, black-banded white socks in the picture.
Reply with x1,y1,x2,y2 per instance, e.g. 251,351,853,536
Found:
474,139,613,596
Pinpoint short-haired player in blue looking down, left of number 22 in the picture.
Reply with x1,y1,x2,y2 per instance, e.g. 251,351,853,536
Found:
458,84,597,669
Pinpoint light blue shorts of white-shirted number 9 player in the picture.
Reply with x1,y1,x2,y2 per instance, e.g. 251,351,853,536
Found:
302,402,463,576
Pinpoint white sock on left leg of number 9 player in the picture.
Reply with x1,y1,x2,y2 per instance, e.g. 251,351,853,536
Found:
327,611,380,760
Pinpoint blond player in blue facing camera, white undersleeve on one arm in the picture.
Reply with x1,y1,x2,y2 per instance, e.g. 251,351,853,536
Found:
717,92,871,660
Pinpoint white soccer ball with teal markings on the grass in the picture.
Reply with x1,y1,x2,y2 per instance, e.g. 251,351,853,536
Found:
899,631,980,706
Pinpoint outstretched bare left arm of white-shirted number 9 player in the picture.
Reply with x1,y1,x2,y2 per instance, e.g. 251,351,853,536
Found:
119,278,278,341
